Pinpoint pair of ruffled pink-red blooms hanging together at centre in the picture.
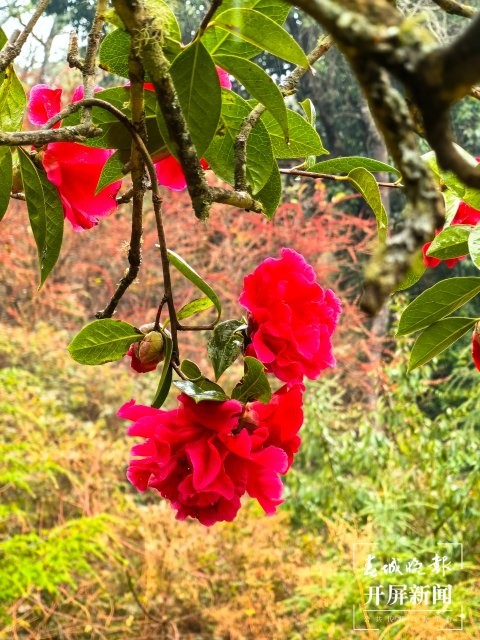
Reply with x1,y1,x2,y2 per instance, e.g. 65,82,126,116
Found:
122,248,341,525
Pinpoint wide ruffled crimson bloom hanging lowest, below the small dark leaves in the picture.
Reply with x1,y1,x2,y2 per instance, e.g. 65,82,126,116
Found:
122,385,304,526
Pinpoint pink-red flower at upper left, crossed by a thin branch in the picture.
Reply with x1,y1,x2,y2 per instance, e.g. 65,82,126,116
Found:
28,85,121,231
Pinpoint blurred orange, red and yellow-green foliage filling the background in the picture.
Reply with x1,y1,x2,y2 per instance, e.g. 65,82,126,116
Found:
0,0,480,640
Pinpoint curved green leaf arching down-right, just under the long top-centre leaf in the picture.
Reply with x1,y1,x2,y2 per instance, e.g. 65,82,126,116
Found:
216,56,289,142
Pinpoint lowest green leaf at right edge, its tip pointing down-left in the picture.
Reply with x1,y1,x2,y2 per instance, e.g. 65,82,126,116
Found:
408,318,478,371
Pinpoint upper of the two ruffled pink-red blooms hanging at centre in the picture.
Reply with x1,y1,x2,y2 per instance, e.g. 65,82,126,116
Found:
239,248,341,383
